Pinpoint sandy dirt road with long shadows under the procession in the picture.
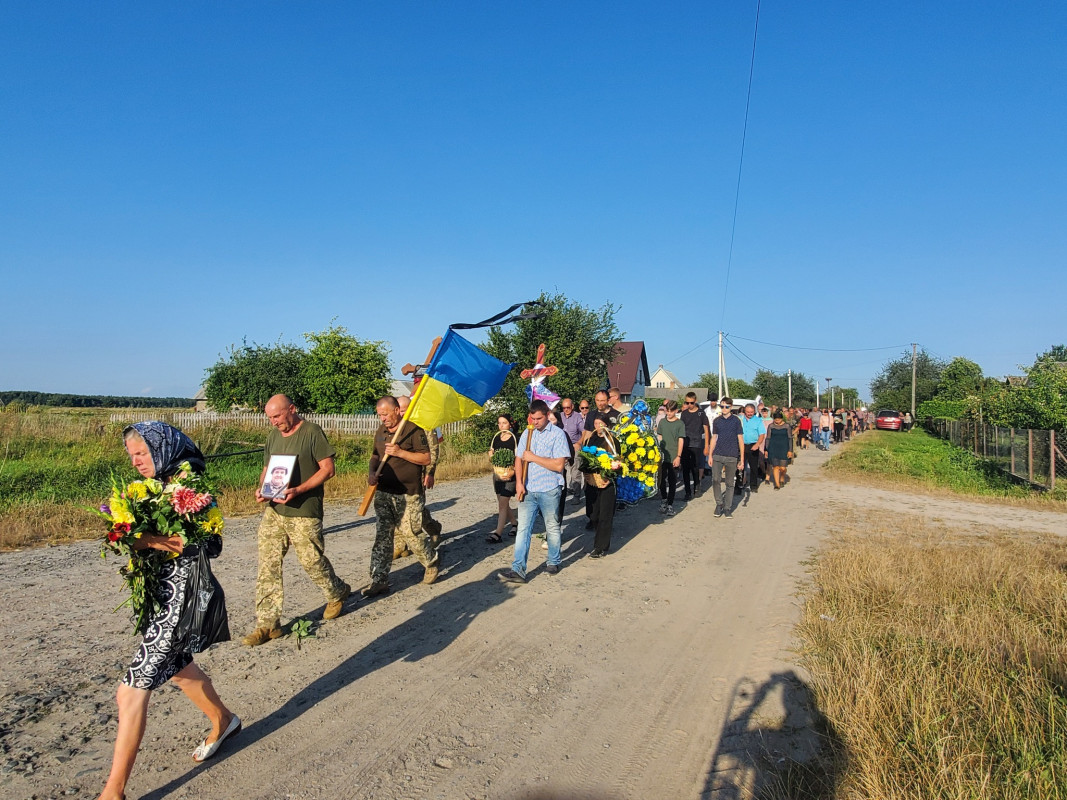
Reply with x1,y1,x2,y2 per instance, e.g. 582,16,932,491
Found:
0,450,1067,800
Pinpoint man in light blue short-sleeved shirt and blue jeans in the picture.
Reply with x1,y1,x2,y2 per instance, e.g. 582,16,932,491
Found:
499,400,571,583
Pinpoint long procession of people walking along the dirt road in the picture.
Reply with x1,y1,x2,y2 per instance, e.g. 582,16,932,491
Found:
93,388,867,798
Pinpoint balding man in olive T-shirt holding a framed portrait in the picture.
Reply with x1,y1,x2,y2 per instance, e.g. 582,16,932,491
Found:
241,395,351,647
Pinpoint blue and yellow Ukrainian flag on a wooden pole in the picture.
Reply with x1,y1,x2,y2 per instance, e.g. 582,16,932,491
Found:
407,329,514,431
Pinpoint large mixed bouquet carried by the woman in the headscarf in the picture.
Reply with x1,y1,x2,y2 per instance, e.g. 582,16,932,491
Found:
90,462,223,634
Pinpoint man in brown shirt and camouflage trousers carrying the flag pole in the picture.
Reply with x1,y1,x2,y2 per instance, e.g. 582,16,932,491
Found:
362,395,437,597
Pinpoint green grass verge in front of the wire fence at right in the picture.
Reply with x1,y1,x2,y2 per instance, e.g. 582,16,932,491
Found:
826,428,1067,510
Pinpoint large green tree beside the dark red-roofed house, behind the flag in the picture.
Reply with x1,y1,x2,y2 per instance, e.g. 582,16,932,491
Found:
476,293,622,435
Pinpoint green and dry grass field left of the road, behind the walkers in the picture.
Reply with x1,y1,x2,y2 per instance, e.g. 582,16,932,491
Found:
0,409,490,549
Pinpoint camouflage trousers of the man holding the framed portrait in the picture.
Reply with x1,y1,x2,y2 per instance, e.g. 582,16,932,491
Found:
256,509,349,627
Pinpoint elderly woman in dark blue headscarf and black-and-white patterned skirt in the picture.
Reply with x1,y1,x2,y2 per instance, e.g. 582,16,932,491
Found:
100,421,241,800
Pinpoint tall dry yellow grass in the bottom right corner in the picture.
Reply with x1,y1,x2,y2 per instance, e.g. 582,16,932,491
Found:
779,511,1067,800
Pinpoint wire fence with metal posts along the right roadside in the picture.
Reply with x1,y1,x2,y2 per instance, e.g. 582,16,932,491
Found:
923,417,1067,491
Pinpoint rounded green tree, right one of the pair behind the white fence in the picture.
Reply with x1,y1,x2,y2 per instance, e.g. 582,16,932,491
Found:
301,324,392,414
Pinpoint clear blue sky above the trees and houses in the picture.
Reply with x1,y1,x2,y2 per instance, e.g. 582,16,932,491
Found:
0,0,1067,396
